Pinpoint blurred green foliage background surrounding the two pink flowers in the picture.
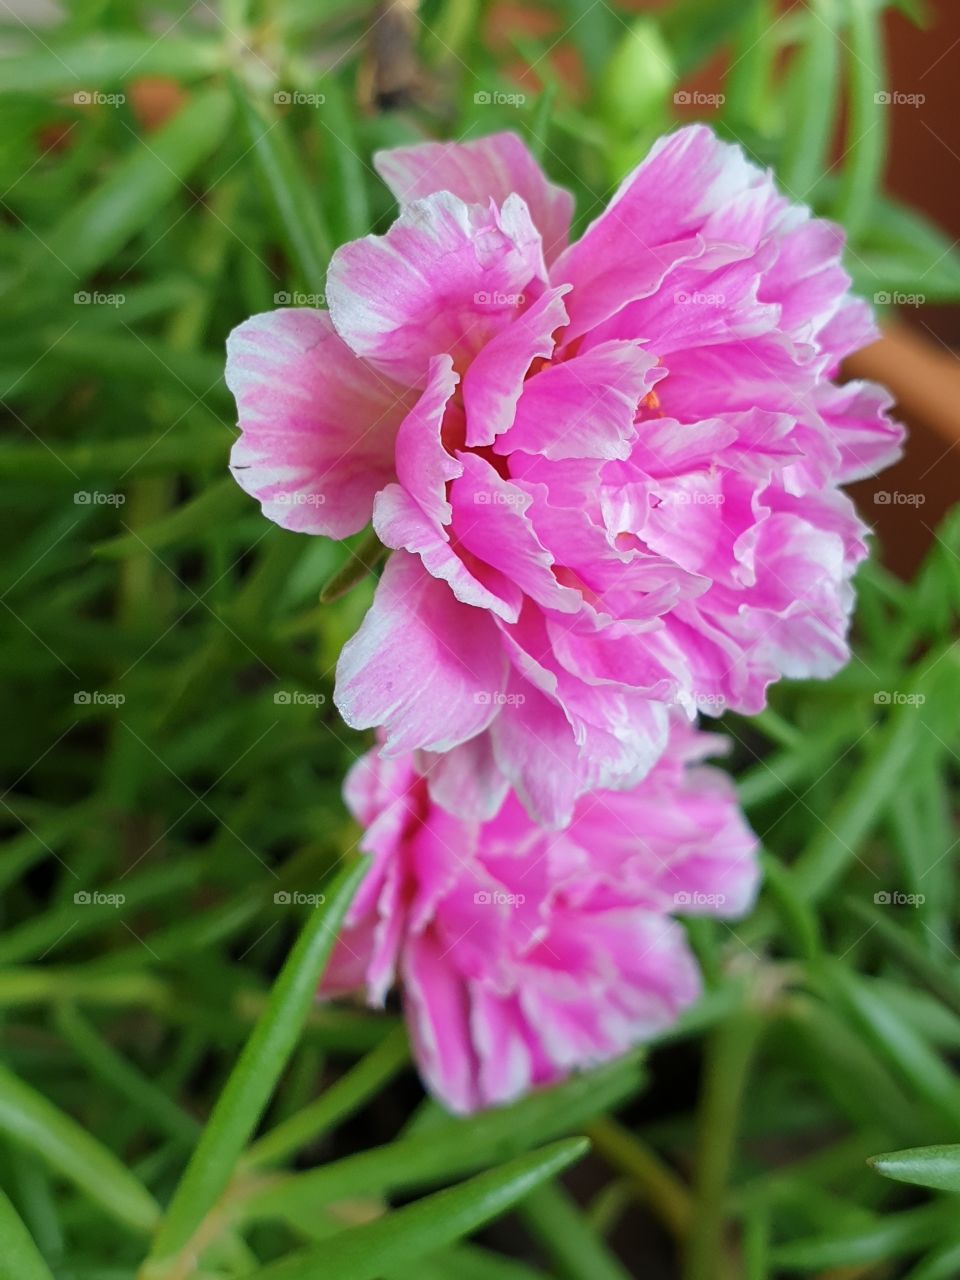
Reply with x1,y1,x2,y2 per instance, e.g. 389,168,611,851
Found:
0,0,960,1280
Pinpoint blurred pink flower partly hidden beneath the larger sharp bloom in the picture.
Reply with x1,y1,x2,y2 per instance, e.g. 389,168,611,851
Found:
324,722,758,1111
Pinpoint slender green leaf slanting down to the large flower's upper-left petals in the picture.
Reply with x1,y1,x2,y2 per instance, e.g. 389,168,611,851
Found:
232,78,333,292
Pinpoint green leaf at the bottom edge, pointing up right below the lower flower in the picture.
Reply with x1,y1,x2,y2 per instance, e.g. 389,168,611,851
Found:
252,1138,590,1280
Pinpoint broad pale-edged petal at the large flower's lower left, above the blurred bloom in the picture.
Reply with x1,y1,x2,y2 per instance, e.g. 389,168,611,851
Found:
334,552,506,755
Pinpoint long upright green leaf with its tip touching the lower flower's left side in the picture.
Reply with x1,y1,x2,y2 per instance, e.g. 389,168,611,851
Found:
145,859,369,1280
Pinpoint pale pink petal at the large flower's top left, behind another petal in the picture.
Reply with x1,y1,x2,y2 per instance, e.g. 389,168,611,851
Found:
374,133,573,262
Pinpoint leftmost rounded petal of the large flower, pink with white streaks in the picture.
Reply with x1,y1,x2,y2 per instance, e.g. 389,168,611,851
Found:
227,307,407,538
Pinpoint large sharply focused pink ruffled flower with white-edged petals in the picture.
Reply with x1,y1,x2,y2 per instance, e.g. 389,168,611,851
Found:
228,125,901,827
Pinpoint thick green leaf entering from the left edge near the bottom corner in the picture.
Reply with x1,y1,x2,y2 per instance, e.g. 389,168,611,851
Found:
0,1066,160,1231
